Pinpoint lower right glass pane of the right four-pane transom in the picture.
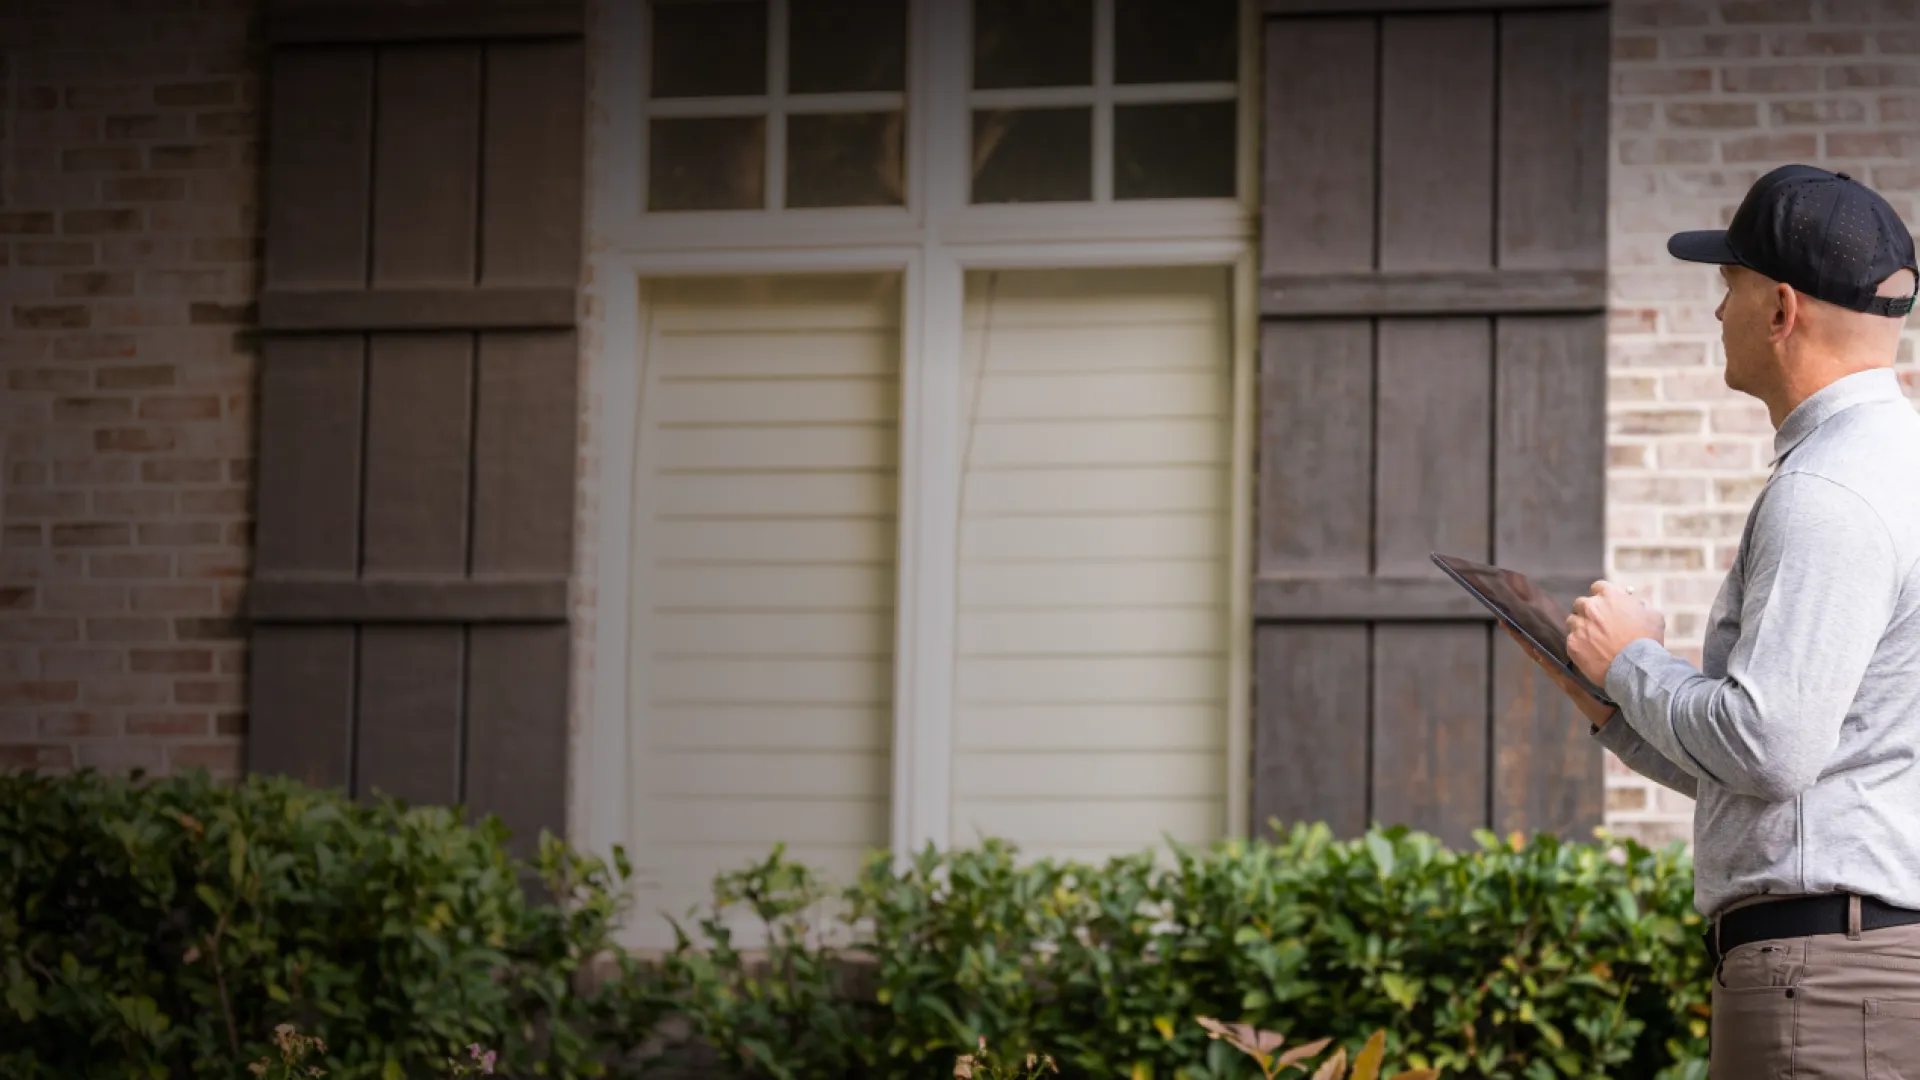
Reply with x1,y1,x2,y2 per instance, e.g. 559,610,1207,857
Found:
1114,102,1235,198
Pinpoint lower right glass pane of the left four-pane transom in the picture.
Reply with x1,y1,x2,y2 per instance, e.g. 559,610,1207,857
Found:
787,111,906,208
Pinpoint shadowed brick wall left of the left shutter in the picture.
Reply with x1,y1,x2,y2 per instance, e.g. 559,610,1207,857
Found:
0,0,261,774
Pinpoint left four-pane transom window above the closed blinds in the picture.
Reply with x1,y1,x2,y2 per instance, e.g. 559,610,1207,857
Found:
647,0,906,211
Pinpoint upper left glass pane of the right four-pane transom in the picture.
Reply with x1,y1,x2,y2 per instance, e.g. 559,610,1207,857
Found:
973,0,1092,90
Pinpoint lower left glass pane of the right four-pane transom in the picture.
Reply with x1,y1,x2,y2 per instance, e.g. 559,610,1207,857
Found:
973,108,1092,202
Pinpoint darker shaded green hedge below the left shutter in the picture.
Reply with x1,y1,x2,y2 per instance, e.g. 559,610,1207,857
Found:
0,774,657,1080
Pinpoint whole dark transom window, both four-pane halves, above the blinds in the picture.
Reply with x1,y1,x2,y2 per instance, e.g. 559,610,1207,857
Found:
645,0,1240,213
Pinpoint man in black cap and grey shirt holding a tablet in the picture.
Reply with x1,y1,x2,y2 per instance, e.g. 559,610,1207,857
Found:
1512,165,1920,1080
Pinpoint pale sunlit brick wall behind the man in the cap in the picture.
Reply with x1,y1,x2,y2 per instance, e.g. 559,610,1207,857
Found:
1607,0,1920,842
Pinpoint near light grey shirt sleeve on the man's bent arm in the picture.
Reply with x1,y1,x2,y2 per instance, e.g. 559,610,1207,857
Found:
1607,473,1899,803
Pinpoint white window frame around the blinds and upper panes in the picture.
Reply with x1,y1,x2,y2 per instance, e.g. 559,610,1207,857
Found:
570,0,1263,880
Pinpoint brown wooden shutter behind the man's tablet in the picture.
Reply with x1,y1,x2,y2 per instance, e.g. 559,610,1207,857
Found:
1252,0,1609,844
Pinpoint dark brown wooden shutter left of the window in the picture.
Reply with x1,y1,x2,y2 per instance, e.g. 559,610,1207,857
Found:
248,0,586,851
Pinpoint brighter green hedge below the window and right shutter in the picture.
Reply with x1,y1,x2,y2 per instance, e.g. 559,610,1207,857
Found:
670,826,1709,1080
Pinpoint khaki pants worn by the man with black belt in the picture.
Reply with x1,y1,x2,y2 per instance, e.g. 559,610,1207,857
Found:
1709,910,1920,1080
